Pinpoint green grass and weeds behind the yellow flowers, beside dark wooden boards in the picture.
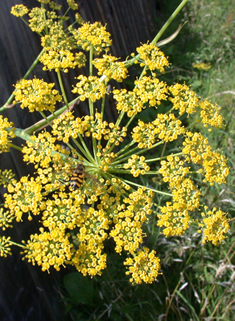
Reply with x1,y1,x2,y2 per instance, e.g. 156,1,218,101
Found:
61,0,235,321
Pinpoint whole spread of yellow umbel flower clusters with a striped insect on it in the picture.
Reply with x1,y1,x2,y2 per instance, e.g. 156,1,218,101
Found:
0,0,229,284
